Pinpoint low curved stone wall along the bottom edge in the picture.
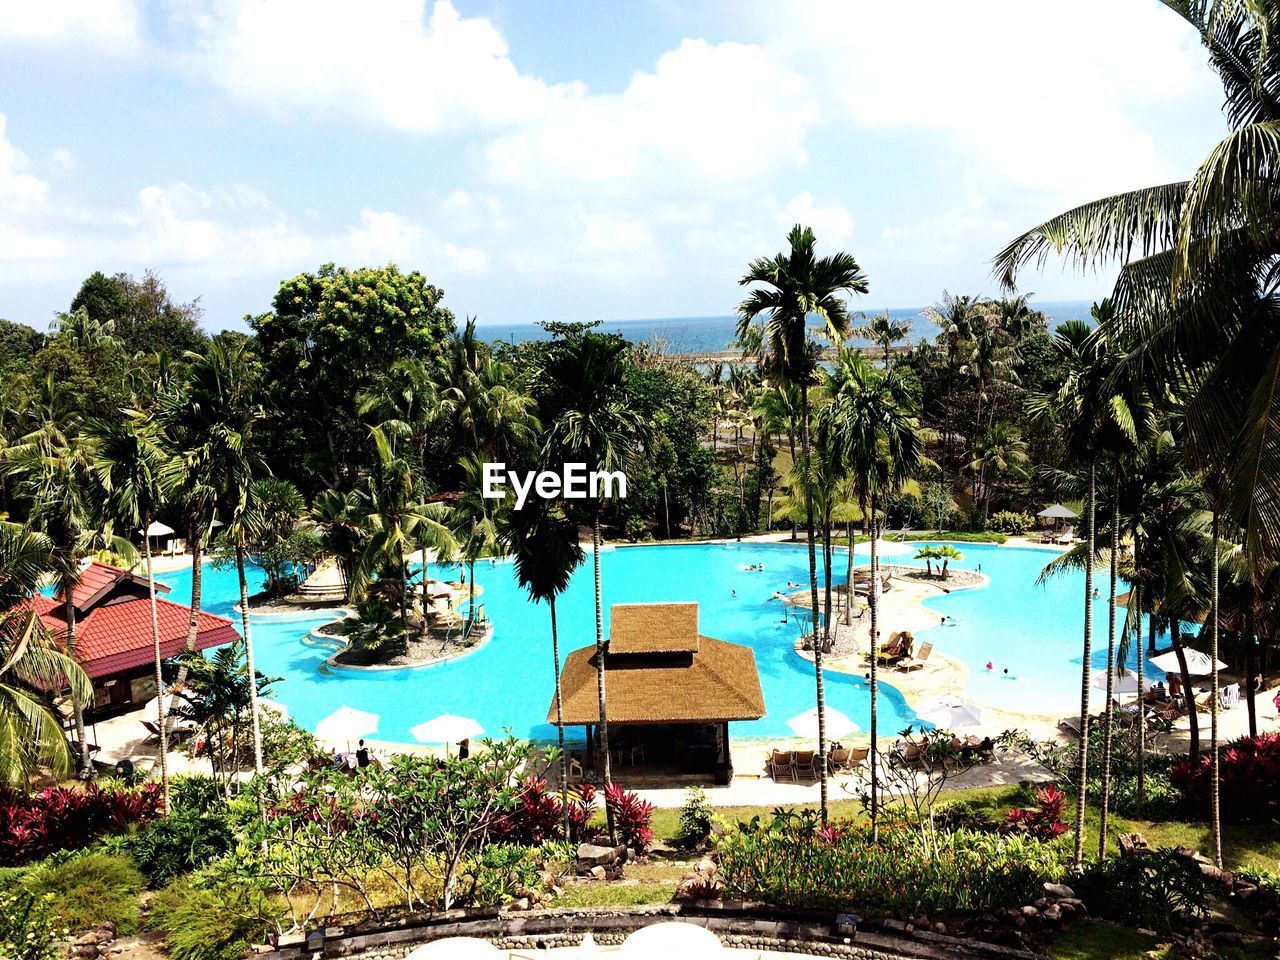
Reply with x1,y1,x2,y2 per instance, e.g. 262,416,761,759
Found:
259,901,1036,960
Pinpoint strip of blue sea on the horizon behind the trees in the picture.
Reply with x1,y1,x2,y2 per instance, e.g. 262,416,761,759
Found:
476,300,1091,355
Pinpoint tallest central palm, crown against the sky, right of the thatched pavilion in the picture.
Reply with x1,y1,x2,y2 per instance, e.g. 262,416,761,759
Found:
737,224,868,823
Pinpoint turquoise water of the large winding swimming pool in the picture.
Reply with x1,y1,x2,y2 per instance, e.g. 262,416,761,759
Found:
157,544,1162,742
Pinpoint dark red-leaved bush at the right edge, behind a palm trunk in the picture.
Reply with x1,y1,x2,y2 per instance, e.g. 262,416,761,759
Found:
1169,733,1280,823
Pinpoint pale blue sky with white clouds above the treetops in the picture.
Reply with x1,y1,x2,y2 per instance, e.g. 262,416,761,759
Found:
0,0,1226,330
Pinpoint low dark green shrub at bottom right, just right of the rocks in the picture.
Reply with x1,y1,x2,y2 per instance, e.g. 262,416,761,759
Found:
1075,847,1212,932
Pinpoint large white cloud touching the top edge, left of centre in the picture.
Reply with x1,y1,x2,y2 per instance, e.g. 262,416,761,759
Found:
184,0,544,132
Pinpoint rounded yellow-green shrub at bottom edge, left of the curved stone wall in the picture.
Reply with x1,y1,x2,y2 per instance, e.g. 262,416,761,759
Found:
147,881,268,960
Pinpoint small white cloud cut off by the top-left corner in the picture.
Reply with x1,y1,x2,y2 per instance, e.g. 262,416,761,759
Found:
0,0,141,54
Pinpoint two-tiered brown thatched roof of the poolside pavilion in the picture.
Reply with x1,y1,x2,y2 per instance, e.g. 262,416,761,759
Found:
547,603,764,726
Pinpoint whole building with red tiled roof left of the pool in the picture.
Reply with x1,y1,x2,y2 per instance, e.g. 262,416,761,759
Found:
21,563,239,710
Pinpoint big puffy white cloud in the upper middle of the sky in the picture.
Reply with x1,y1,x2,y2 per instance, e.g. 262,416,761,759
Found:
485,40,818,195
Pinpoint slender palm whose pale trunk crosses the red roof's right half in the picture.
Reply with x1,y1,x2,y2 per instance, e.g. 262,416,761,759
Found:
84,410,176,809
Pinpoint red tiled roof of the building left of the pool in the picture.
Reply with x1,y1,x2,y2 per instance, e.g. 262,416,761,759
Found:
24,563,239,678
